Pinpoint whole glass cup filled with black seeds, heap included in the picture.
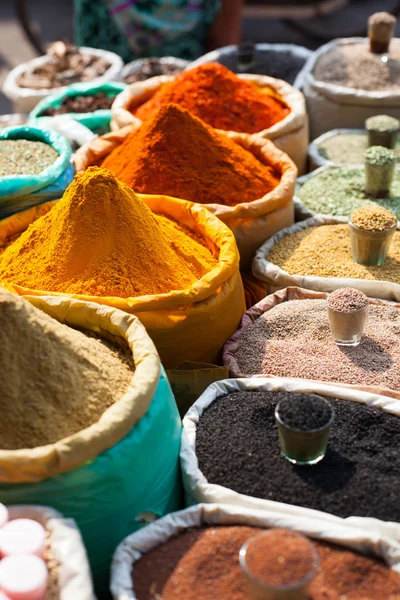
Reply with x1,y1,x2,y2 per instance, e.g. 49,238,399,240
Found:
275,394,334,465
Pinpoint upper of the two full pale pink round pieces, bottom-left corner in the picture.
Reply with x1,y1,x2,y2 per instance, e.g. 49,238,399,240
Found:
0,519,46,558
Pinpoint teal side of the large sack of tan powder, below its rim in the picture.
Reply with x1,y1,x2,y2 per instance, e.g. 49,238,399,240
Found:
0,369,183,600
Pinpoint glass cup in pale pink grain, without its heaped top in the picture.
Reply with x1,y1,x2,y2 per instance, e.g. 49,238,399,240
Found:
327,304,369,346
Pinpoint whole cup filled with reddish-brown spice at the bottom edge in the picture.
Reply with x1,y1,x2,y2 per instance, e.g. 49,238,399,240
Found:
239,529,319,600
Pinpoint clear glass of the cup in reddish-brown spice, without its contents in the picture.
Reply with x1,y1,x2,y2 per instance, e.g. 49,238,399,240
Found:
239,531,319,600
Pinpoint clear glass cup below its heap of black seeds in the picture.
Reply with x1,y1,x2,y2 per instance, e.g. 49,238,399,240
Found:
275,398,335,465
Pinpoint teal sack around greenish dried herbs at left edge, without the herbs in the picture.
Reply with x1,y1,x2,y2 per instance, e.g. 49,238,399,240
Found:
0,126,74,219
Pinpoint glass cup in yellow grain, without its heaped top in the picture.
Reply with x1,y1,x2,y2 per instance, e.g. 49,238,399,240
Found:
349,221,397,267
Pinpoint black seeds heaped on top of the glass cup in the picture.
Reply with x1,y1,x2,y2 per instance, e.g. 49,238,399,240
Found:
279,394,332,431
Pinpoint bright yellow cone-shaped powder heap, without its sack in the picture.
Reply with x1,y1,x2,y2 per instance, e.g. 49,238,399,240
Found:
0,167,217,298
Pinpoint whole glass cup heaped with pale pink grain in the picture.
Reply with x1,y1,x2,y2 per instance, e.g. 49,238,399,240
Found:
327,288,368,346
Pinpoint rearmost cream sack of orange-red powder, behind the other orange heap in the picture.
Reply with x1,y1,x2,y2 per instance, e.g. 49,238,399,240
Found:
111,63,308,174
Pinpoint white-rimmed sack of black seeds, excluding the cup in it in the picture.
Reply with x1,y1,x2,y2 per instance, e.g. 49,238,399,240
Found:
180,377,400,541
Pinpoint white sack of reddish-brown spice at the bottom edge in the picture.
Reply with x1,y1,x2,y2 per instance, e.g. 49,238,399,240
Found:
111,504,400,600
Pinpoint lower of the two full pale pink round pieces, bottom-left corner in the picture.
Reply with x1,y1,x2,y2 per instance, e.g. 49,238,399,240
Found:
0,556,48,600
